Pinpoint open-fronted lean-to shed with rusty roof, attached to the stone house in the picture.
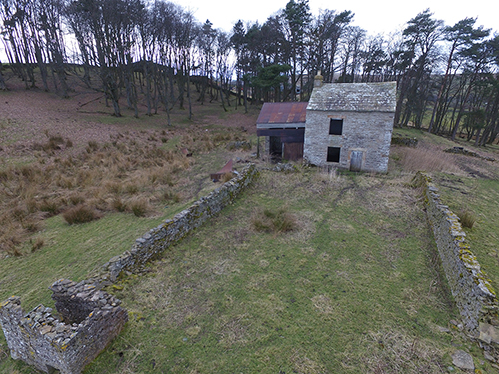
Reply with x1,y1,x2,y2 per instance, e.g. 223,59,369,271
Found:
256,102,307,161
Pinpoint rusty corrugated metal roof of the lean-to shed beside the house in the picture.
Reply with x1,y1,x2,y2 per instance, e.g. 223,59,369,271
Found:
256,102,308,125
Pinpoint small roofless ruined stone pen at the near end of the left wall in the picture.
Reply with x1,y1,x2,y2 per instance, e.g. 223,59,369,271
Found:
0,279,128,374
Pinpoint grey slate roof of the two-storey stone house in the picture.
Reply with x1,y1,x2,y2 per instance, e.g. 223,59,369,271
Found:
307,82,397,112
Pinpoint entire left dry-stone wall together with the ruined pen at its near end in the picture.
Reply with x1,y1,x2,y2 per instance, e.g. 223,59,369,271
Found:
0,164,257,374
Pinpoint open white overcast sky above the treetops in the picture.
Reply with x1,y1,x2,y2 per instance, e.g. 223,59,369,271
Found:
182,0,499,35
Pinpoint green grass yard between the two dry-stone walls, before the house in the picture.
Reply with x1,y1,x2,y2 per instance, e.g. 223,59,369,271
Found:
74,171,476,374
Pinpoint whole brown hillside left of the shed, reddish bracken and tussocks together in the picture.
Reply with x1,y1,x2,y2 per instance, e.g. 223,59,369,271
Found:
0,81,256,257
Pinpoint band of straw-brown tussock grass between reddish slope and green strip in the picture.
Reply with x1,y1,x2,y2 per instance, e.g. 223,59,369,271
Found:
0,130,237,256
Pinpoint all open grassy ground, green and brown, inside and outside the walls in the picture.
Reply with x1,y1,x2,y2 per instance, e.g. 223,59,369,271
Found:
0,81,499,374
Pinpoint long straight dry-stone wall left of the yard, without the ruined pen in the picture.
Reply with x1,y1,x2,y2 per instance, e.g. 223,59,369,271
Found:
96,164,257,282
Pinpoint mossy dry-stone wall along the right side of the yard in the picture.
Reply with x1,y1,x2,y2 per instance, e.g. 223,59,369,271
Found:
415,172,499,344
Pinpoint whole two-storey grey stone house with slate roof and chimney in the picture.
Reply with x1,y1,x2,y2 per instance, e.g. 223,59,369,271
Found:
303,75,397,172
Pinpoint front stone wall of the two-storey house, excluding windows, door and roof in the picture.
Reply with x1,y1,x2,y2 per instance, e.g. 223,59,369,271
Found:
303,110,394,173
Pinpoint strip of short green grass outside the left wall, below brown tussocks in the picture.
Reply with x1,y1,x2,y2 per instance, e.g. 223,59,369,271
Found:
0,213,182,310
